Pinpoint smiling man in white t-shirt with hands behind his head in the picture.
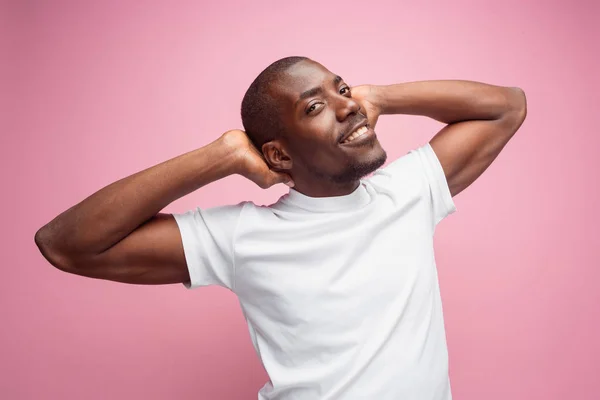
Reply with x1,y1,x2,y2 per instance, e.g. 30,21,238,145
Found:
35,57,526,400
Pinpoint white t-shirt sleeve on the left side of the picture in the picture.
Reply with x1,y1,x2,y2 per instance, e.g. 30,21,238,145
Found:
173,202,245,291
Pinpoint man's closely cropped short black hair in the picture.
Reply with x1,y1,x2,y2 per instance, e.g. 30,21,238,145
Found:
242,56,308,152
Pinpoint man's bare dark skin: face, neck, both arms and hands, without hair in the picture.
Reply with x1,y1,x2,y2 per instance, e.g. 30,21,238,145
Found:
35,60,527,285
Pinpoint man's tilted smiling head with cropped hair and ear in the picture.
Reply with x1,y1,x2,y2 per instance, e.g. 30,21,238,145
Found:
242,57,386,191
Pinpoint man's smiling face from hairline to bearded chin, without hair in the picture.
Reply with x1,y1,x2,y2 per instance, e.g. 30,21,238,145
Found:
270,60,387,184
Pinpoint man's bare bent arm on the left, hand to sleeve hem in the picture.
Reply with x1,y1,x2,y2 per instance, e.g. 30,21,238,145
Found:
35,130,289,284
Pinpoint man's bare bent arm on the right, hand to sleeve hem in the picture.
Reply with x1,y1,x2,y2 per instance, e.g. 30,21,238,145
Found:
352,80,527,196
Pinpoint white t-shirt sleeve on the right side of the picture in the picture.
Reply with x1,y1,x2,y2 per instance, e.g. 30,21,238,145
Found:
409,143,456,225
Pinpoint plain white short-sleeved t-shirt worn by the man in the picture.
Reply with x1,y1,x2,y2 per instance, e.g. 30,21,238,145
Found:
175,144,456,400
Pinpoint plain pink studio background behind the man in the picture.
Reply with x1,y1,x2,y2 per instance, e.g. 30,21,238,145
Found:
0,0,600,400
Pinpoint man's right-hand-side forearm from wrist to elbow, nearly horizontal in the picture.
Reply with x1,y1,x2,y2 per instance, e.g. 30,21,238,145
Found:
374,80,523,124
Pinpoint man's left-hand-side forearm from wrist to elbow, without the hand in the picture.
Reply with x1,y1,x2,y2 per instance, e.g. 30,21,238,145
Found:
35,138,236,255
